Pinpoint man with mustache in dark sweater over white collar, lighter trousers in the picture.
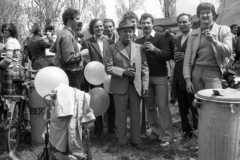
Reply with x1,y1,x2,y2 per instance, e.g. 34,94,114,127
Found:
136,13,173,146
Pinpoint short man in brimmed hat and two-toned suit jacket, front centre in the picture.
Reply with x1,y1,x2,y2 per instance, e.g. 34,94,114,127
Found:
105,20,149,149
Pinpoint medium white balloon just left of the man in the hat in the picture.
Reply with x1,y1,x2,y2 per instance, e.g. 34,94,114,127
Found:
84,61,107,85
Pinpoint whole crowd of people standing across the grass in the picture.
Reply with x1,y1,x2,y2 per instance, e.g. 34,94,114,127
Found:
0,3,236,158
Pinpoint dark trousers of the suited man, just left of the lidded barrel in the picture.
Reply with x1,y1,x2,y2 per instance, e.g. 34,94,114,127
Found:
177,89,198,132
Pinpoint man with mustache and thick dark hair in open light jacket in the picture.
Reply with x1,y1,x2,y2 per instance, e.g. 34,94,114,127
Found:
183,3,233,93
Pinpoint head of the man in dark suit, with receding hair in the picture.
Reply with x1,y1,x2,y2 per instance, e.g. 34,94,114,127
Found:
177,13,192,34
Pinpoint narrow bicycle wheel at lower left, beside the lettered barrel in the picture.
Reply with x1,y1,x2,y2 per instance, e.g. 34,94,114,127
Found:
7,102,20,151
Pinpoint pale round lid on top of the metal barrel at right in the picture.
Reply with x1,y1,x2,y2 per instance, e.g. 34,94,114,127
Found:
195,89,240,104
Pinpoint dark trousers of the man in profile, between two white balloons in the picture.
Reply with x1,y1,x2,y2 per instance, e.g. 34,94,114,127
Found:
65,71,83,89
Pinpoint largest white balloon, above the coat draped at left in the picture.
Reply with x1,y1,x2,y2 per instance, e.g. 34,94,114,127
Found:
34,66,69,99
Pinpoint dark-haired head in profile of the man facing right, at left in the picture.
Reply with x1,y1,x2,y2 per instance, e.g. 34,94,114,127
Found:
62,8,80,30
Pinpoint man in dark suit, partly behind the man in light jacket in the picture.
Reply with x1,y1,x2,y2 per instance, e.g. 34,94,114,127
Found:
173,13,198,140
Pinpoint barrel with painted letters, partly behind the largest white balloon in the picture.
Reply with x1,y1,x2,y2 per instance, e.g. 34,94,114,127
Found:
28,84,45,145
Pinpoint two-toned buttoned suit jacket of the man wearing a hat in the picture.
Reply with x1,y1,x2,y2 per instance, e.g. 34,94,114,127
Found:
105,41,149,96
